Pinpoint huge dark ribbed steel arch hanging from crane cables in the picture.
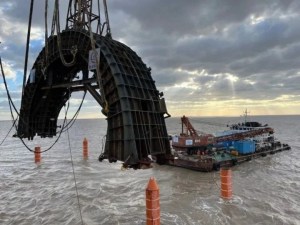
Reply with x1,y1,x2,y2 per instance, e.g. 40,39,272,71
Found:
18,29,170,166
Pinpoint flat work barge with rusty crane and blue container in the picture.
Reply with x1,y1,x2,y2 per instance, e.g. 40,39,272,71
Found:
168,116,290,172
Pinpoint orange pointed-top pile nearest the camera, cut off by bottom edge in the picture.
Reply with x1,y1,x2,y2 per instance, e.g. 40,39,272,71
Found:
146,177,160,225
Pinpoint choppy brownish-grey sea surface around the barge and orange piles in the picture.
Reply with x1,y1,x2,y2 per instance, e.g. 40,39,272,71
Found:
0,116,300,225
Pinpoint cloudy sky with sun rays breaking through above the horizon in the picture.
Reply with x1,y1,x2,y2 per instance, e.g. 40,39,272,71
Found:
0,0,300,119
